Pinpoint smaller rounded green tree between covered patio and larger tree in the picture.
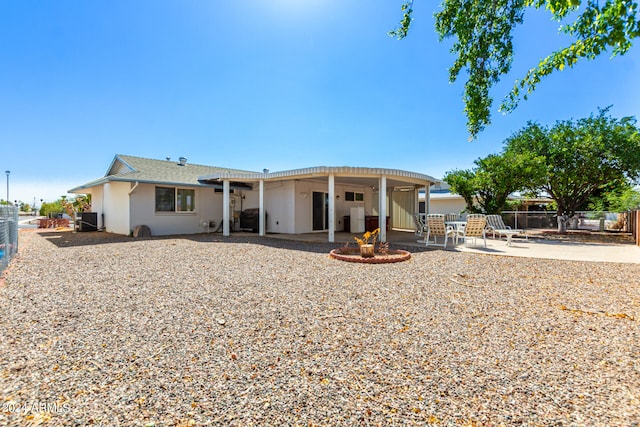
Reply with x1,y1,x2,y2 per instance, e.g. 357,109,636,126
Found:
444,152,544,214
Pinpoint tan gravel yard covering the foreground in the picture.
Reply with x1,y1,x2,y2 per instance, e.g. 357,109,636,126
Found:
0,231,640,426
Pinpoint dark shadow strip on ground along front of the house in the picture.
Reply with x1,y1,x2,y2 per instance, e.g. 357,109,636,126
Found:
39,231,434,254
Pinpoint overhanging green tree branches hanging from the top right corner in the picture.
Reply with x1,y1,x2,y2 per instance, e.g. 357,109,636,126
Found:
389,0,640,139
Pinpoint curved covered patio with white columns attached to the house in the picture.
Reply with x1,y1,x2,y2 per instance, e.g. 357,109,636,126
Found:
198,166,438,242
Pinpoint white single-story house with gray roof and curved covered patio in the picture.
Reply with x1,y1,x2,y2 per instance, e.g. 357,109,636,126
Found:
69,154,439,242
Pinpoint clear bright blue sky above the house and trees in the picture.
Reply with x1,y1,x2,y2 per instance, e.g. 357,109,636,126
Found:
0,0,640,204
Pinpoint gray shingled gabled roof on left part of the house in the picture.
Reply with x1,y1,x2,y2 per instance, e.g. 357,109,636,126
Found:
69,154,251,193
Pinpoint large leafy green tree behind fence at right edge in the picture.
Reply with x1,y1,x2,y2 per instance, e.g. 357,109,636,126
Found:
505,109,640,231
